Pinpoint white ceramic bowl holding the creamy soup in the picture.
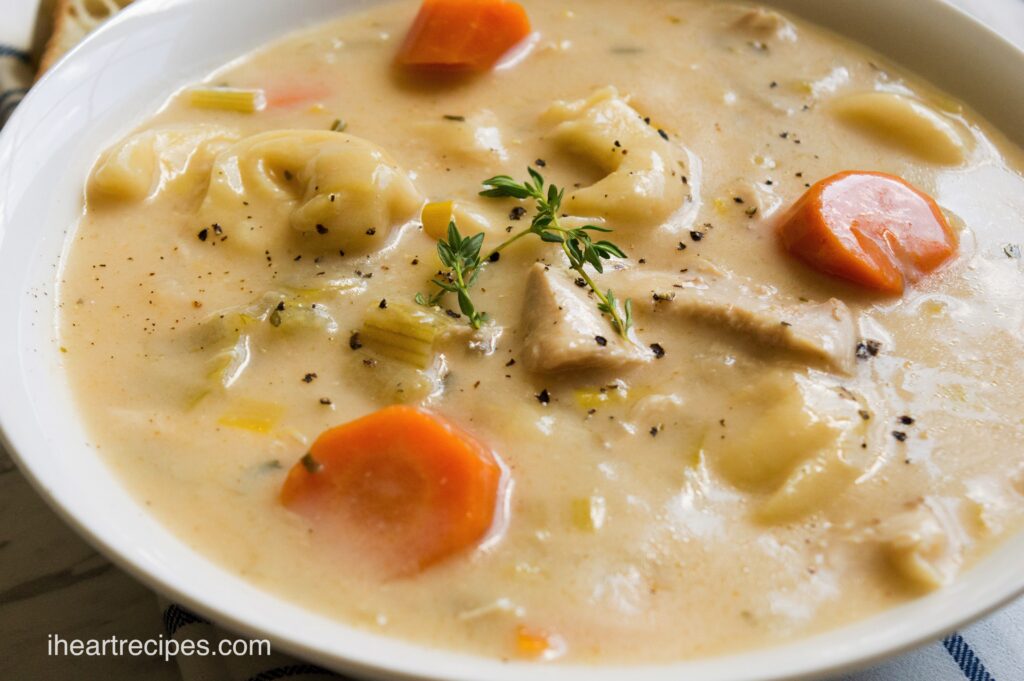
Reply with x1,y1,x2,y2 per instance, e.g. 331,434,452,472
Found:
0,0,1024,681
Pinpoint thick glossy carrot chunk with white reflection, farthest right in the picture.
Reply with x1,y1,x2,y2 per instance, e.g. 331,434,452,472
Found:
778,171,957,294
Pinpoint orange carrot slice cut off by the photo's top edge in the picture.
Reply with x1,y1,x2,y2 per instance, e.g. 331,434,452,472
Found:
397,0,530,71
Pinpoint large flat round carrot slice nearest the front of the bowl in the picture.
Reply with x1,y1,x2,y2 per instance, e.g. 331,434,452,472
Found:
281,406,502,573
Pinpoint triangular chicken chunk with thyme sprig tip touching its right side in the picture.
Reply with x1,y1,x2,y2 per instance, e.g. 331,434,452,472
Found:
522,263,653,372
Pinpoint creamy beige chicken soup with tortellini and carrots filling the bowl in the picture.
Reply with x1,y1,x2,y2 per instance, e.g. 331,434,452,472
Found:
60,0,1024,663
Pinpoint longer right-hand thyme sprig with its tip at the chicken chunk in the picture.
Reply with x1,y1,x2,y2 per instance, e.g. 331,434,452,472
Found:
480,168,633,338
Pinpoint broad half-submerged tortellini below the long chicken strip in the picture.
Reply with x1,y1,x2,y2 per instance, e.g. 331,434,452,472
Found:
707,373,866,522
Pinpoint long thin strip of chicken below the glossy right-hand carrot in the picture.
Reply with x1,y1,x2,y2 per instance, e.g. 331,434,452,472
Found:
615,271,857,373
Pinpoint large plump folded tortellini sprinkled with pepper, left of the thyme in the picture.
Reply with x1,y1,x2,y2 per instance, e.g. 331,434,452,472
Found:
201,130,423,254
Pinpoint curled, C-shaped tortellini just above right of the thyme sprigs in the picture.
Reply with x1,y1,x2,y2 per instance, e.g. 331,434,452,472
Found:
545,87,689,226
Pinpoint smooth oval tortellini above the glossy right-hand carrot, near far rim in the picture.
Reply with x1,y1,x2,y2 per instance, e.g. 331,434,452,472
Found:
833,92,968,165
